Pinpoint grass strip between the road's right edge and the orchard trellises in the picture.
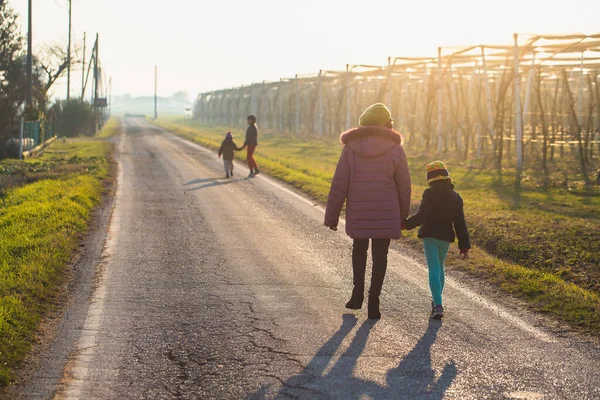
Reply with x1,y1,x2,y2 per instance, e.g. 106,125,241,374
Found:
154,118,600,334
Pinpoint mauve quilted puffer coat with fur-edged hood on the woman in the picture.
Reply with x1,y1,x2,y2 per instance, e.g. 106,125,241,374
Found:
325,126,411,239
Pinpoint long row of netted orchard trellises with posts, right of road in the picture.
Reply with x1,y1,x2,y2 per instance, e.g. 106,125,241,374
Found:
194,34,600,184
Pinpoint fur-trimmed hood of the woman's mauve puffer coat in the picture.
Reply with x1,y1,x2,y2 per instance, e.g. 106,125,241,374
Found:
340,126,402,157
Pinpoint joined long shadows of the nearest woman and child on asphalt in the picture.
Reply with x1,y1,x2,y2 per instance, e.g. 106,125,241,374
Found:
249,314,457,400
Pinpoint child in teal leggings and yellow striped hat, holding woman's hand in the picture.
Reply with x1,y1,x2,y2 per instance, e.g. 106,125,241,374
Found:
404,161,471,319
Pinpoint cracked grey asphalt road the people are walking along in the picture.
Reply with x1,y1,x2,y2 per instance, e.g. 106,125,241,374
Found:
18,120,600,399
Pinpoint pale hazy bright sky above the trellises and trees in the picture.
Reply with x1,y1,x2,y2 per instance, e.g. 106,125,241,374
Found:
7,0,600,99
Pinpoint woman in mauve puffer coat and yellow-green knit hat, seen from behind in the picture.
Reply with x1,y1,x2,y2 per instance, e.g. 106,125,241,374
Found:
325,103,411,319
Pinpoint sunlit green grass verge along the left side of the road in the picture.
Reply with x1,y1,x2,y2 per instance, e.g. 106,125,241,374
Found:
0,141,110,386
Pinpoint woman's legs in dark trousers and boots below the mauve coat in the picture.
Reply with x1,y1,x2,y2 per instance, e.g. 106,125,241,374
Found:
346,239,390,319
